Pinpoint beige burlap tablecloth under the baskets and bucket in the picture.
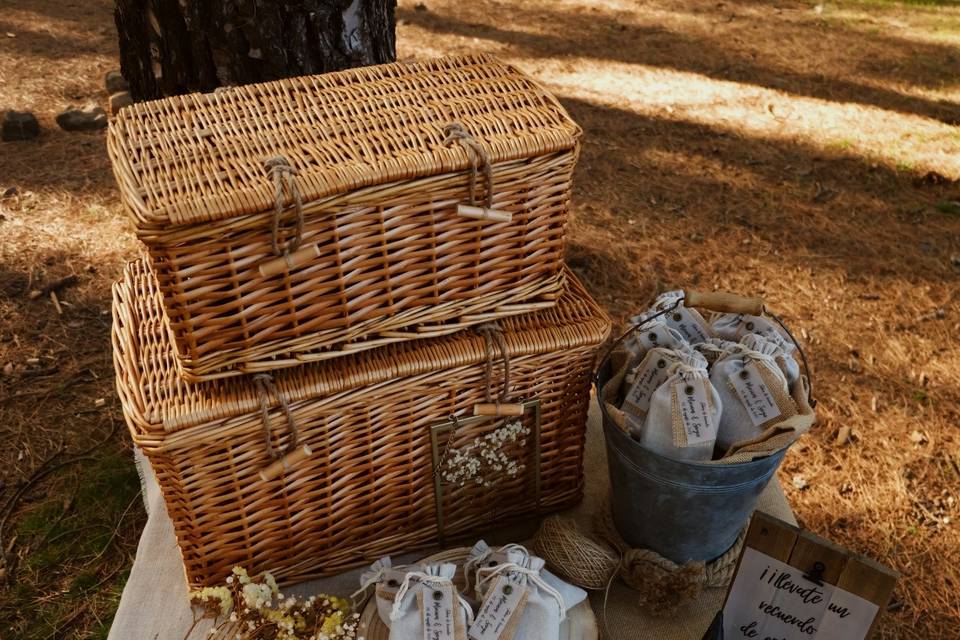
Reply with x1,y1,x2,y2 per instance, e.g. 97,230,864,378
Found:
108,402,796,640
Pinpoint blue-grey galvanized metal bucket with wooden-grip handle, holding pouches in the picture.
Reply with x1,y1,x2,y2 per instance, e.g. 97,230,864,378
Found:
595,293,806,564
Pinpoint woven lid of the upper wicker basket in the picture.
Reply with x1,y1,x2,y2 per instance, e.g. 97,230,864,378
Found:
107,55,581,229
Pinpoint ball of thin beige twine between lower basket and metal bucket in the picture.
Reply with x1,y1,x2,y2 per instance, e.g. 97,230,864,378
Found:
533,516,620,590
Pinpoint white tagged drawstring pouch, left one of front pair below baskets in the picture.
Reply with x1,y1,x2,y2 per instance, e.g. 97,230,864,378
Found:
390,563,473,640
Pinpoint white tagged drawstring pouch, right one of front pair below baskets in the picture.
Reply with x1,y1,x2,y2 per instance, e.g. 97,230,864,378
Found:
468,541,587,640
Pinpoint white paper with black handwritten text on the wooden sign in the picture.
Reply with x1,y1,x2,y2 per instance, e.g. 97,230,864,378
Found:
723,547,878,640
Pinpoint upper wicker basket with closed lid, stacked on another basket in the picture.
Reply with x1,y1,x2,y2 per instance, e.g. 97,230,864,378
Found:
108,56,581,381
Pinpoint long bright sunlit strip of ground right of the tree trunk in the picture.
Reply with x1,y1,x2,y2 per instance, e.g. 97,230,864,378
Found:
535,58,960,178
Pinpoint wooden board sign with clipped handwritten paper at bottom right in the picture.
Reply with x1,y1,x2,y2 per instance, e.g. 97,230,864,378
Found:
715,512,900,640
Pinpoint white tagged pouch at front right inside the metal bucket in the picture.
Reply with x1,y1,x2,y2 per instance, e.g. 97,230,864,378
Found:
710,335,799,451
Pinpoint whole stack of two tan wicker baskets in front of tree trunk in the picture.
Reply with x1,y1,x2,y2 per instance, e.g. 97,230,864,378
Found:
109,56,609,585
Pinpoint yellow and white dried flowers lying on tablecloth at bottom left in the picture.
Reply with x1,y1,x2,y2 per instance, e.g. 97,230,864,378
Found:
187,567,363,640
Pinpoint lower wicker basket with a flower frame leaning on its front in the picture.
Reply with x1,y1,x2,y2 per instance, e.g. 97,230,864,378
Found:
113,255,610,585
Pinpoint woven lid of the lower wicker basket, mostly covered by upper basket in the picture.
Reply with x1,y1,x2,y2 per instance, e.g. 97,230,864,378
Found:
113,259,611,437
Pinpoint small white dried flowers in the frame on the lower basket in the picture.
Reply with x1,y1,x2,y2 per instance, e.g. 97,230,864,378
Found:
441,420,530,487
